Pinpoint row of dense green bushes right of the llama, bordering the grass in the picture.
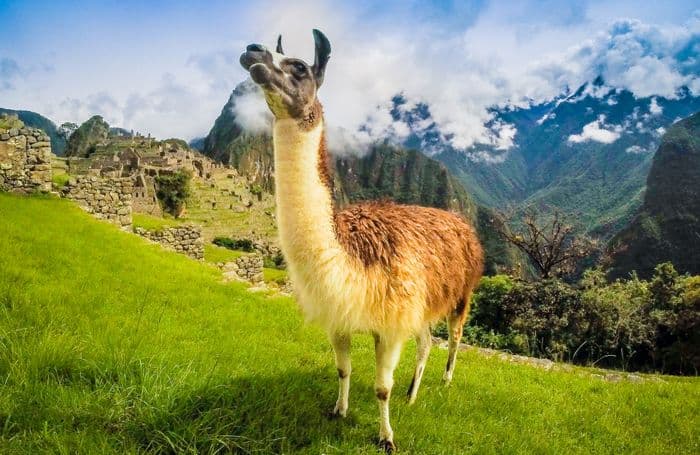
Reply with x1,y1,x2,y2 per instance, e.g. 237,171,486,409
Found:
460,263,700,374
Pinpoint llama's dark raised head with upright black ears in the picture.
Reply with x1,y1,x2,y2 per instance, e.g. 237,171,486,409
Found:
240,29,331,124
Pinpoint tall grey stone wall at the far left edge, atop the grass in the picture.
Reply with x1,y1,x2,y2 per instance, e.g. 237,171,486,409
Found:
0,121,52,193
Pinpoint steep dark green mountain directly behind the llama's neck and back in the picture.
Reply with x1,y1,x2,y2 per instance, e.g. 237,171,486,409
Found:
203,82,517,272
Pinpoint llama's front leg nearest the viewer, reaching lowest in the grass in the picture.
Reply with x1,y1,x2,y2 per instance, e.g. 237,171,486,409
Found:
374,335,402,453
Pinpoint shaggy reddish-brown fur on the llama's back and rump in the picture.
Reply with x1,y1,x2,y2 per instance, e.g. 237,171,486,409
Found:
335,202,483,321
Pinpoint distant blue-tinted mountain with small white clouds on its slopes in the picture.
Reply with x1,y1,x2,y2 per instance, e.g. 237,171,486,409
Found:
426,79,700,239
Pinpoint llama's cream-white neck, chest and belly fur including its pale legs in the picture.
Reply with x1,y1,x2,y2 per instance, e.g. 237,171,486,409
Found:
268,116,438,449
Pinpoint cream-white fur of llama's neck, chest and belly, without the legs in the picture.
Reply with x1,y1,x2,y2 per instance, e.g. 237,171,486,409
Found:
274,119,427,336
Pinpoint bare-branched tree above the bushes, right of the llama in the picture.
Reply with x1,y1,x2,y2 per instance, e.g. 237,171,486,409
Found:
494,210,597,279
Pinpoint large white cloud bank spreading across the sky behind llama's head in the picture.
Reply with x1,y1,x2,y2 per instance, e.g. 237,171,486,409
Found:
0,0,700,159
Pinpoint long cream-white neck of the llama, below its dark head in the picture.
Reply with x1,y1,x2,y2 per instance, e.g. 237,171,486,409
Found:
273,119,341,271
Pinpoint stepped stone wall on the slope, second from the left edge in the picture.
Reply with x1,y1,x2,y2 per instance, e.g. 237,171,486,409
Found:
61,175,134,229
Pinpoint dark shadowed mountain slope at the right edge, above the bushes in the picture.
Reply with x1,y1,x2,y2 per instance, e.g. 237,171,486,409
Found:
609,112,700,278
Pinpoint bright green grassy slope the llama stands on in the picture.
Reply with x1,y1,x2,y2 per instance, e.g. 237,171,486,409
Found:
0,194,700,454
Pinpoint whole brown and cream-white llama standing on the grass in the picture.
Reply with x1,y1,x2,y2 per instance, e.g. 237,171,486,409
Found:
240,30,483,453
